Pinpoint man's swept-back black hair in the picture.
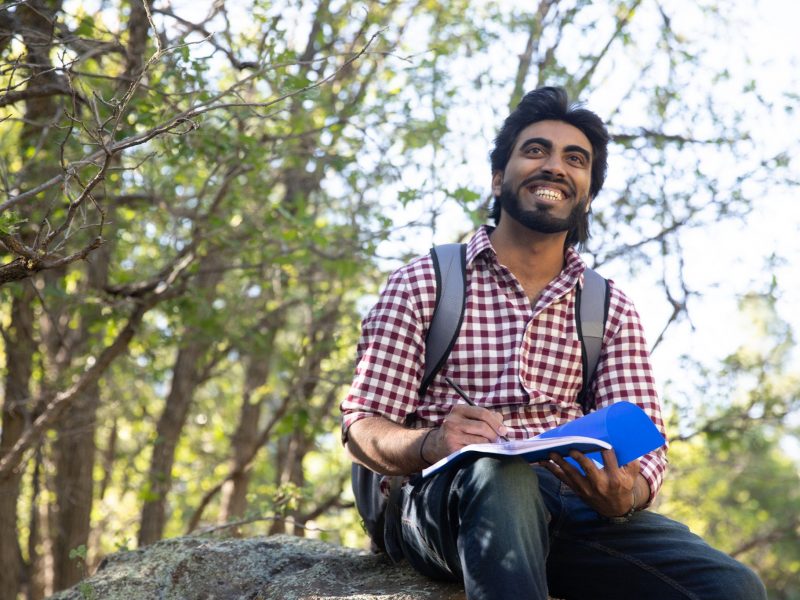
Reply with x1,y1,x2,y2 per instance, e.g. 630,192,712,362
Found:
489,87,610,246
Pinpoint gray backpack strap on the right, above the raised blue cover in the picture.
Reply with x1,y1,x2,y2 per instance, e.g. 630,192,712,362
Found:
575,267,609,413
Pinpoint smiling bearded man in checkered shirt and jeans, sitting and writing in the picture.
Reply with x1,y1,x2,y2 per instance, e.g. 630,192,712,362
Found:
342,88,766,600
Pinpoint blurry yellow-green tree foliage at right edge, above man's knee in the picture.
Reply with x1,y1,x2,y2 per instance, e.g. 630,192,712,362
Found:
659,288,800,600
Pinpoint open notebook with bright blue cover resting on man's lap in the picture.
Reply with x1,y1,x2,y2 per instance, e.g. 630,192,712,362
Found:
422,402,665,477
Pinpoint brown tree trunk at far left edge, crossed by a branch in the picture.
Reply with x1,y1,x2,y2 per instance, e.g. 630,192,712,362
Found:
0,282,36,599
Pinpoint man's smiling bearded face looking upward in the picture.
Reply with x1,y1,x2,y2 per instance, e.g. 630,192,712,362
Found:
492,121,592,233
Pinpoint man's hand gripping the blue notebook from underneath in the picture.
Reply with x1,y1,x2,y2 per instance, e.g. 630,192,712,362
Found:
541,450,639,517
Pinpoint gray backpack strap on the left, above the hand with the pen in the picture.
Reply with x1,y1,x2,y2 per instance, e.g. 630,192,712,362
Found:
419,244,467,396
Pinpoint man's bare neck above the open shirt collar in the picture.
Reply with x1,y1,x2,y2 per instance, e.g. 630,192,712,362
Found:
490,214,567,300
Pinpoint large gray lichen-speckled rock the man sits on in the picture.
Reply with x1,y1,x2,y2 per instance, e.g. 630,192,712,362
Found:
51,535,464,600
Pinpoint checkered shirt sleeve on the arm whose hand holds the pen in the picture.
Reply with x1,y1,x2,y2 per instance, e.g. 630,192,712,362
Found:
340,259,436,441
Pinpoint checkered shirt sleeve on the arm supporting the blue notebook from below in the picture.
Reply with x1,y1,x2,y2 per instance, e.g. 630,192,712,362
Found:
592,281,667,502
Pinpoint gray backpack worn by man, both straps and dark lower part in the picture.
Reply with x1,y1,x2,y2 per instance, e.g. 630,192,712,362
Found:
350,244,610,559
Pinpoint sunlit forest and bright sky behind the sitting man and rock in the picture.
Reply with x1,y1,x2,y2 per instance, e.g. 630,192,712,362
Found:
0,0,800,600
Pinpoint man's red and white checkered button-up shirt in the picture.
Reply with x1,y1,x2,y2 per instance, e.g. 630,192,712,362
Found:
341,226,667,499
